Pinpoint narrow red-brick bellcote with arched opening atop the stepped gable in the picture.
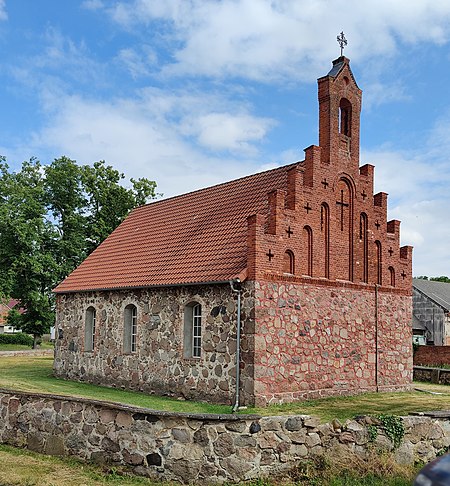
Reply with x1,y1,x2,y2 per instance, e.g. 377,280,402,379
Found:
318,56,362,170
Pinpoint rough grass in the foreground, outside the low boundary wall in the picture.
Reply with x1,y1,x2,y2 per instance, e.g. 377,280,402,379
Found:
0,445,418,486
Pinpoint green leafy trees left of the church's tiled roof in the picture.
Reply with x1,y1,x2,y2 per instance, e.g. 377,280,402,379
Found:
0,157,156,344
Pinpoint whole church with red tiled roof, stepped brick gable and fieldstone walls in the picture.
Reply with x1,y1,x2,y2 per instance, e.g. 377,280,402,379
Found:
55,57,412,404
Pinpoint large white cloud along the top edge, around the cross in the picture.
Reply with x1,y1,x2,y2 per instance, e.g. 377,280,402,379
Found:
103,0,450,80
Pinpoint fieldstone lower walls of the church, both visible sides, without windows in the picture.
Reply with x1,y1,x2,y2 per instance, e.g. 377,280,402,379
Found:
54,276,412,405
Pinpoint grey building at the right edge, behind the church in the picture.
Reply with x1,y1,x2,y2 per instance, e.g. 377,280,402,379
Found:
413,278,450,346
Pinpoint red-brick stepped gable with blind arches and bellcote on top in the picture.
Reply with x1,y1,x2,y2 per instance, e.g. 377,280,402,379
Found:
244,58,412,293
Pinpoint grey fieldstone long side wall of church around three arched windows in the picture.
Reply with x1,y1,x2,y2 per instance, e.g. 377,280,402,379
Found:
54,284,254,404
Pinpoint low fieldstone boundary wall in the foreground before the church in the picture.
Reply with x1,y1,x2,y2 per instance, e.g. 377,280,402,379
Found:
0,389,450,484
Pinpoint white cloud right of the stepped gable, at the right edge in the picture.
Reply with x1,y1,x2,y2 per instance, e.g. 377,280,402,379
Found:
361,120,450,276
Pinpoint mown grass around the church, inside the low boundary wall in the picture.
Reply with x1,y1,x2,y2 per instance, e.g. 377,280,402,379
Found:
0,356,450,421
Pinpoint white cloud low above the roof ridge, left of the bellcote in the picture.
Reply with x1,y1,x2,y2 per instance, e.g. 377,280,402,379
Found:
17,90,269,196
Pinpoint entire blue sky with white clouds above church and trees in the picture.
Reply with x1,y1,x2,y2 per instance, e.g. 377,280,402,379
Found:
0,0,450,276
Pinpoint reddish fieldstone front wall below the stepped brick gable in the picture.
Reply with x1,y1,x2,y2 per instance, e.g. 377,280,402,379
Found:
254,280,413,405
